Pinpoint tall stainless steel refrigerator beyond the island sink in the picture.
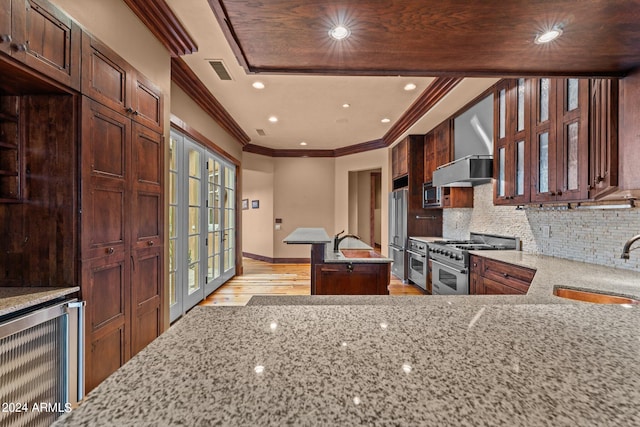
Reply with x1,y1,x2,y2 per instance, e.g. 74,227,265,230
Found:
389,188,409,282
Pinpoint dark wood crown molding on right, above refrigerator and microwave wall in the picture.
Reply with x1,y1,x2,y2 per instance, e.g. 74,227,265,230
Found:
382,77,462,146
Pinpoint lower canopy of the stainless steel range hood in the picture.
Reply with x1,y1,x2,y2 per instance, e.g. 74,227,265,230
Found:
433,154,493,187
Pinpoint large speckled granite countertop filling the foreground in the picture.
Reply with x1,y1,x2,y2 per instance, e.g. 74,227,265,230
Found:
54,304,640,426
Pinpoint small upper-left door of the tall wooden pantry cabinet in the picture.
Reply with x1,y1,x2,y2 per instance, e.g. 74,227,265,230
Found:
82,33,133,114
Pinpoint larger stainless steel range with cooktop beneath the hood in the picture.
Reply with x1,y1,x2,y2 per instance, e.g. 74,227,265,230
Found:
429,233,520,295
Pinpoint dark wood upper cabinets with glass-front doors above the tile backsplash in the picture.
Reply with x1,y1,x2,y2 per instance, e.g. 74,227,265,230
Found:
494,78,618,205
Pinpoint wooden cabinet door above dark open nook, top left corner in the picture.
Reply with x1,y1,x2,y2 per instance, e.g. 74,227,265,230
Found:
19,0,82,89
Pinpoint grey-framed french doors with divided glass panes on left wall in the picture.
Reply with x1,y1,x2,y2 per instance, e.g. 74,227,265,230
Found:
169,130,236,322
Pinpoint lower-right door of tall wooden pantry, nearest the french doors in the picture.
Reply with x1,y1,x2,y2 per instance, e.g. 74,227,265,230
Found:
131,247,163,356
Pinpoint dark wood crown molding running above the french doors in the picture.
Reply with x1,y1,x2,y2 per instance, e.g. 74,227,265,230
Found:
171,57,251,146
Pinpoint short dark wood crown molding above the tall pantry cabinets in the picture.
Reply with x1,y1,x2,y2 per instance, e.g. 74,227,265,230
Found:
124,0,198,57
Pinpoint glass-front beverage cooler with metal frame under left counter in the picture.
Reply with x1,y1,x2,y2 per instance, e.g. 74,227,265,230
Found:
0,299,84,426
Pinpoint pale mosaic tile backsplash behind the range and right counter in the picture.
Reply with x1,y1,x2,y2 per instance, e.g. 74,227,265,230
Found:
443,184,640,271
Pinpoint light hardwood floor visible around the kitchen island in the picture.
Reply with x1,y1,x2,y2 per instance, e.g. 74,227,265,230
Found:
200,258,424,306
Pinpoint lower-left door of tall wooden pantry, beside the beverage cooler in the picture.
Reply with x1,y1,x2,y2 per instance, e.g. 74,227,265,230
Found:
81,254,131,392
